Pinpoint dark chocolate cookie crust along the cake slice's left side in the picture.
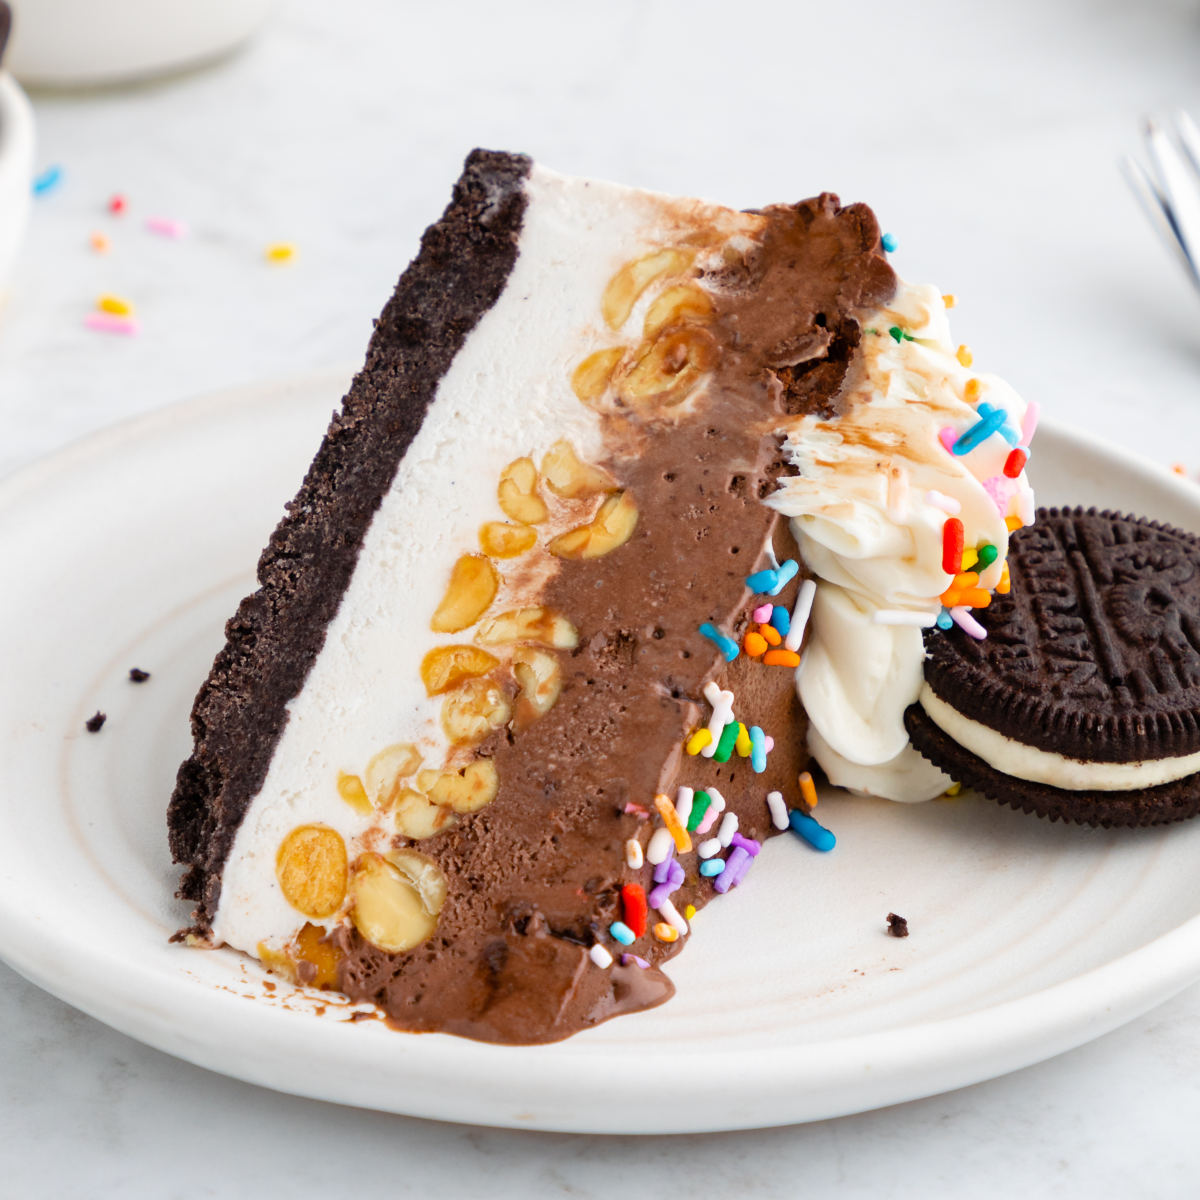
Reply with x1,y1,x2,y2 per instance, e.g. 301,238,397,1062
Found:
168,150,532,936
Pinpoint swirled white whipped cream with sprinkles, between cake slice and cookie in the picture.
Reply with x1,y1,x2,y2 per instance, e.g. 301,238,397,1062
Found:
767,283,1033,802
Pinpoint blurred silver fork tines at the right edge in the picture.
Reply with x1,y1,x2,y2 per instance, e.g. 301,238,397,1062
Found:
1122,112,1200,288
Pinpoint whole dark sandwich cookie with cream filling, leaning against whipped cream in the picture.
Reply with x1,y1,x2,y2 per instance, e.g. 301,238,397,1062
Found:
905,508,1200,827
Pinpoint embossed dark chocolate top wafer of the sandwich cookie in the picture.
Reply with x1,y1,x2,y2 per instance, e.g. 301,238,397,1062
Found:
925,508,1200,764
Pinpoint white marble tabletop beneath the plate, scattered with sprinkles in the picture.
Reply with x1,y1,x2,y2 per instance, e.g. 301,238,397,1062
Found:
0,0,1200,1198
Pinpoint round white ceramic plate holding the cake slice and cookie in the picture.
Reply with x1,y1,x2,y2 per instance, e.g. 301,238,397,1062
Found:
0,376,1200,1133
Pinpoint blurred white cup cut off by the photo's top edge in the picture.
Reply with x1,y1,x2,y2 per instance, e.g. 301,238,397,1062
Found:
6,0,272,88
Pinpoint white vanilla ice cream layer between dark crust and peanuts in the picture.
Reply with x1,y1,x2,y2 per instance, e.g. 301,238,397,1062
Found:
212,166,756,953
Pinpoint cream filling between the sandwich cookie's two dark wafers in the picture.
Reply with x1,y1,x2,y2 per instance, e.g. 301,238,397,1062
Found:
918,684,1200,792
